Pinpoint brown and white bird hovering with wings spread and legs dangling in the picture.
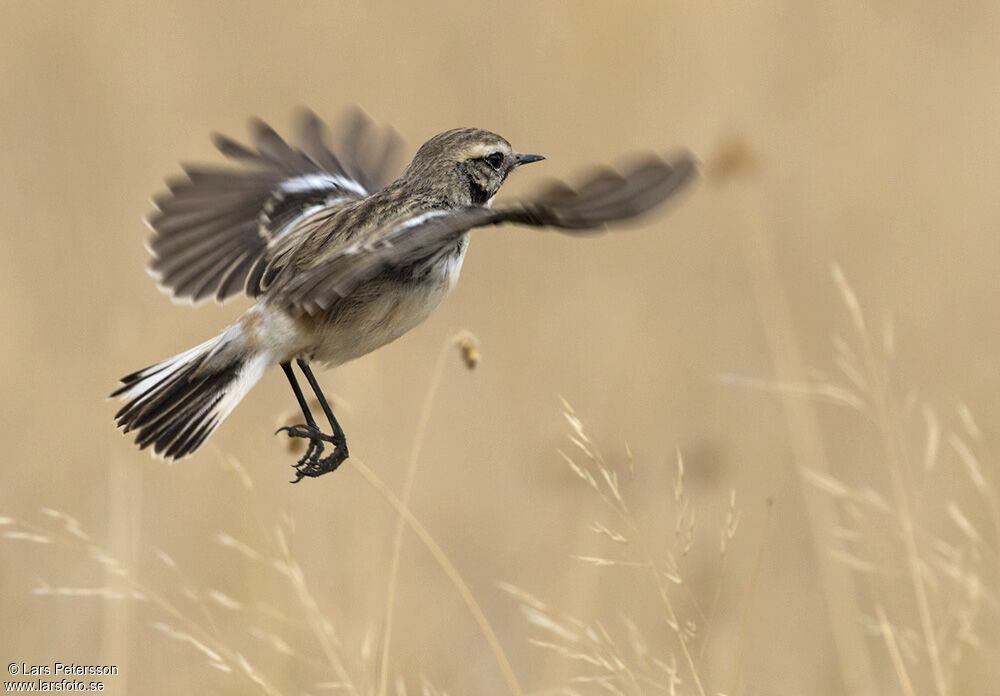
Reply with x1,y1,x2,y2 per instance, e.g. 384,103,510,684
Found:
111,109,697,483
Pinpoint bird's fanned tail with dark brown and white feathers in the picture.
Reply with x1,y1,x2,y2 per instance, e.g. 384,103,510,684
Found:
111,327,268,460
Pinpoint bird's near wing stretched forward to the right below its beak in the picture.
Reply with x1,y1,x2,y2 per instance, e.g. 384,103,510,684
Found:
268,153,696,314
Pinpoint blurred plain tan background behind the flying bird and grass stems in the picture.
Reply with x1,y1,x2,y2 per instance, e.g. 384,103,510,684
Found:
0,0,1000,696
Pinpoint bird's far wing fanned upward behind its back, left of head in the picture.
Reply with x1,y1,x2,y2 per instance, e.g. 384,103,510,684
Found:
147,110,400,302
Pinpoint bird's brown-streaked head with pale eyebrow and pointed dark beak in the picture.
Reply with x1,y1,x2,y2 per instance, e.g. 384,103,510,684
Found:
403,128,545,205
